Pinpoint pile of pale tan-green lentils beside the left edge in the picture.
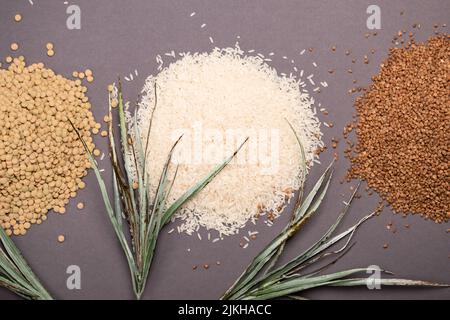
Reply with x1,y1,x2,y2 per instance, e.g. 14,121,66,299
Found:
0,57,100,235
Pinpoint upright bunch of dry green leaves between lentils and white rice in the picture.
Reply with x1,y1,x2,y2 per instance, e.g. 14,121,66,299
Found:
77,79,247,299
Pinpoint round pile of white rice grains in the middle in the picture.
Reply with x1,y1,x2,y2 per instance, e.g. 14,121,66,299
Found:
131,47,323,237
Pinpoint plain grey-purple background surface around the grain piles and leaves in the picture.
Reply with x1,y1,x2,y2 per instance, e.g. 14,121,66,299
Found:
0,0,450,299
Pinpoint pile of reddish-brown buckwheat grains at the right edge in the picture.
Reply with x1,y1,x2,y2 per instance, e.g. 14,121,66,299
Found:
349,34,450,223
